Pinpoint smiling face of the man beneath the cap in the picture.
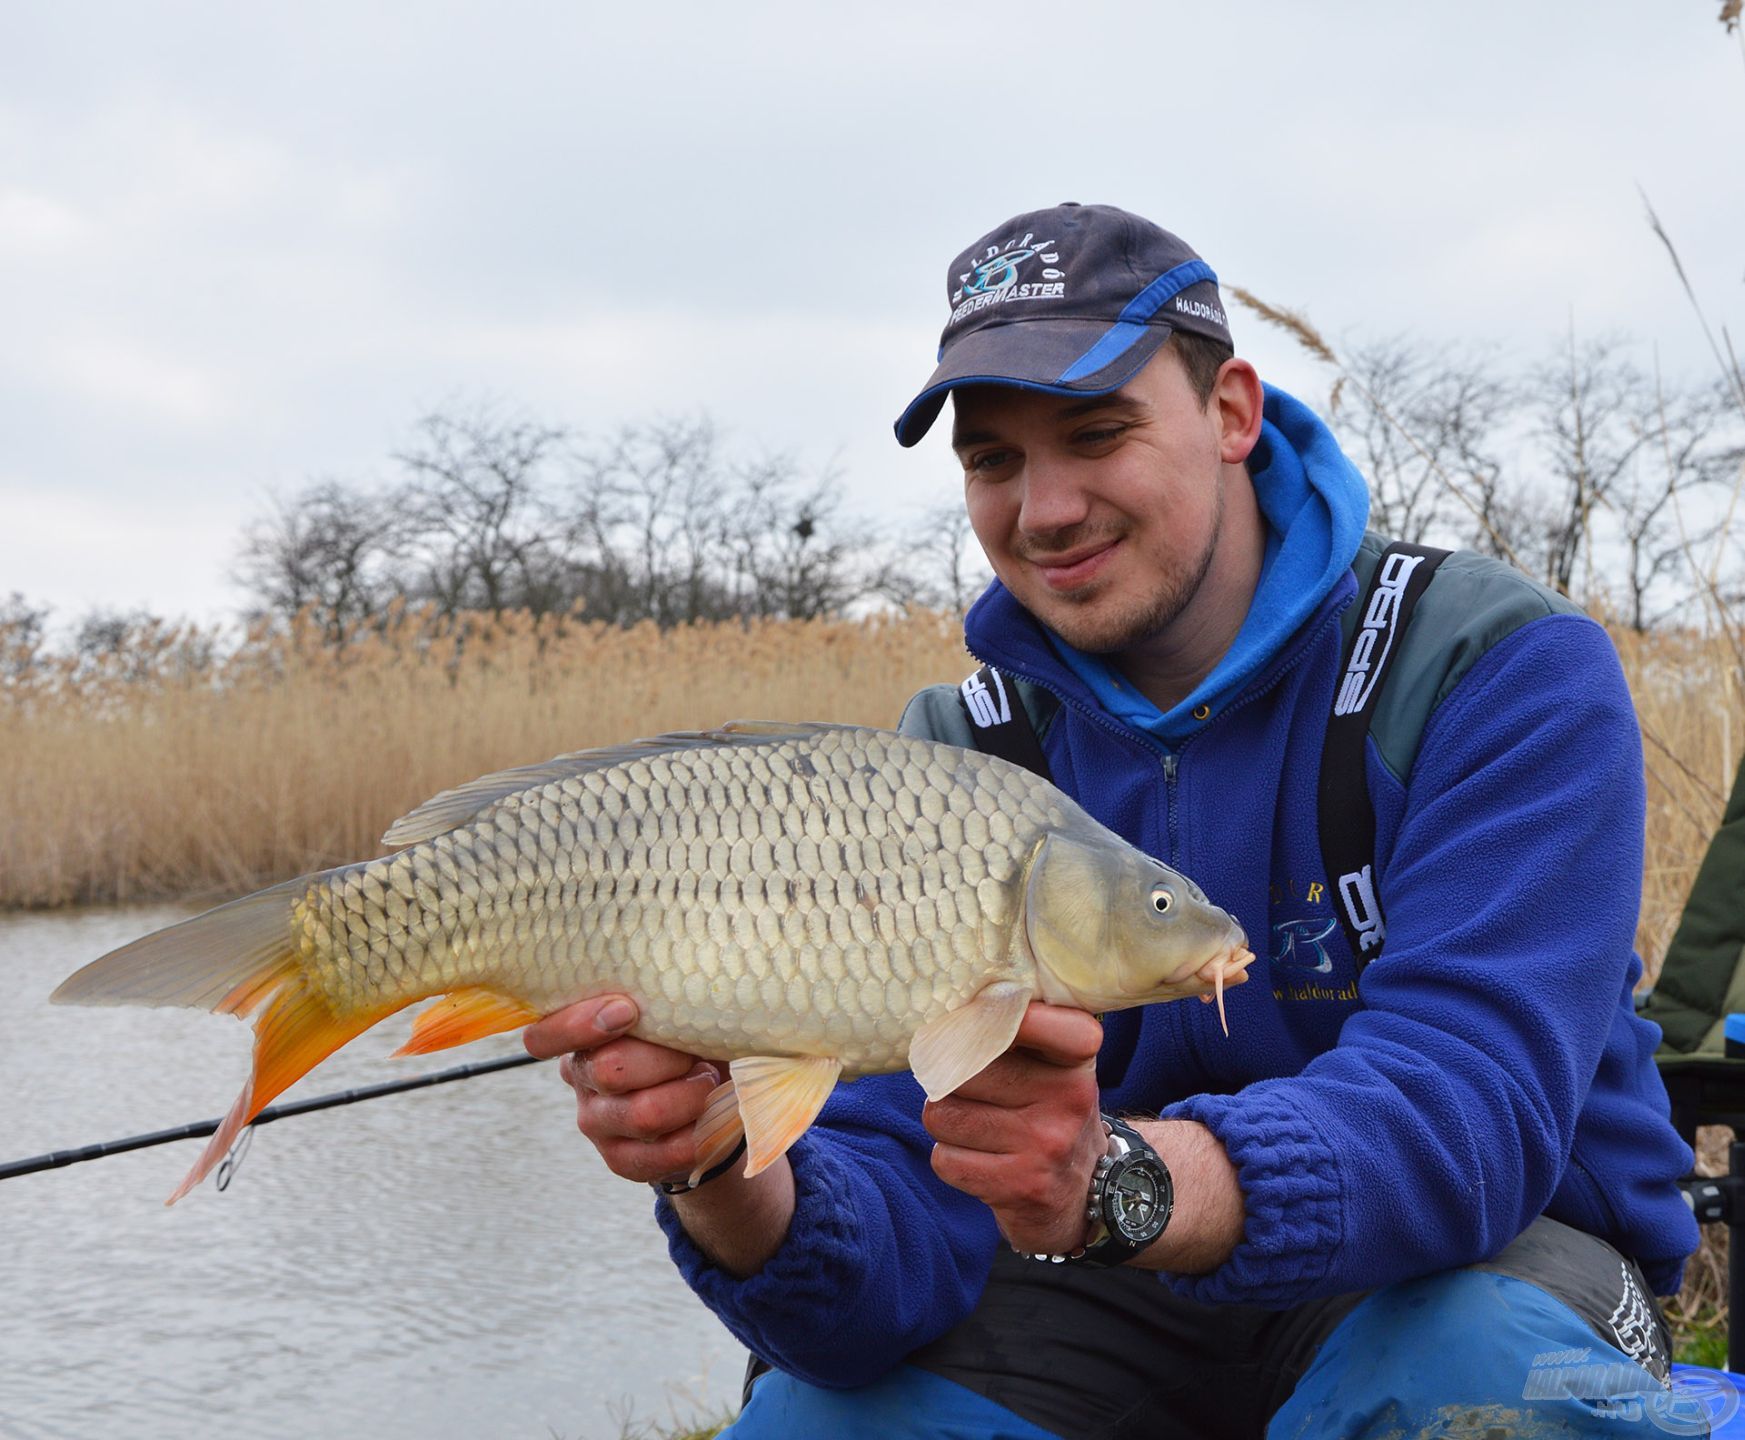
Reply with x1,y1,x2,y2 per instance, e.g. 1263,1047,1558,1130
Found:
951,349,1223,655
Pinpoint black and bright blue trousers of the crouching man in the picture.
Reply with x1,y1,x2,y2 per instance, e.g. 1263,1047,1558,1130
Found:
724,1220,1714,1440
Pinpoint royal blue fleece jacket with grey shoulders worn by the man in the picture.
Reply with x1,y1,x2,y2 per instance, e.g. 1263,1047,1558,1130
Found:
658,387,1696,1386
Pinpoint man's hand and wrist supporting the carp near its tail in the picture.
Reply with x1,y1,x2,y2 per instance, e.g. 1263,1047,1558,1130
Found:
522,995,794,1276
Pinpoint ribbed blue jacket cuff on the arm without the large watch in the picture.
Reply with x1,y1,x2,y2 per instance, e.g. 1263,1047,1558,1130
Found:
654,1135,866,1358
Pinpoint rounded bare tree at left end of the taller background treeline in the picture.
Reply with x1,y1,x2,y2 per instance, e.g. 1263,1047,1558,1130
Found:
232,480,408,639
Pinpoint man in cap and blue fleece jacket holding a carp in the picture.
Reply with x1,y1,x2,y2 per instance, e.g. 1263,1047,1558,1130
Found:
527,206,1696,1438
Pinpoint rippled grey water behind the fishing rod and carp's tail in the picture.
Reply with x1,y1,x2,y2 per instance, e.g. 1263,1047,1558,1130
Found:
0,908,745,1440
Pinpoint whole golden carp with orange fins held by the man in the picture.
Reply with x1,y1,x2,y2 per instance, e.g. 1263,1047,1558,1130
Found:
52,721,1253,1204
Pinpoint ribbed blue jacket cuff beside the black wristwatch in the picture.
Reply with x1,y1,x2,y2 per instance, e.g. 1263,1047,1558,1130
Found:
1162,1082,1345,1309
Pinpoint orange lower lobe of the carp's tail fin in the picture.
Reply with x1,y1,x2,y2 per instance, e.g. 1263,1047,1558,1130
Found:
164,955,405,1204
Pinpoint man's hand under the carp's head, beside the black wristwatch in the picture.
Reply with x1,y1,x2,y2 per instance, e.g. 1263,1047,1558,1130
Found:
921,1002,1105,1253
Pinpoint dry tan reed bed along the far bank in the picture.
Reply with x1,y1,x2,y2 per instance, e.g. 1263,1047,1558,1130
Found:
0,596,1745,1342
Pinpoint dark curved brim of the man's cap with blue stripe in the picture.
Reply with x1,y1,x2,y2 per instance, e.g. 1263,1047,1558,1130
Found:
895,318,1173,447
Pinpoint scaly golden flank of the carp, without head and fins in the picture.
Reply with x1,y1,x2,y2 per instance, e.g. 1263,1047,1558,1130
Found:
287,730,1040,1073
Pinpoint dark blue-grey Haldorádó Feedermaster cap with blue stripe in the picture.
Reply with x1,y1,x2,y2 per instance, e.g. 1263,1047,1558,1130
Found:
897,204,1232,445
